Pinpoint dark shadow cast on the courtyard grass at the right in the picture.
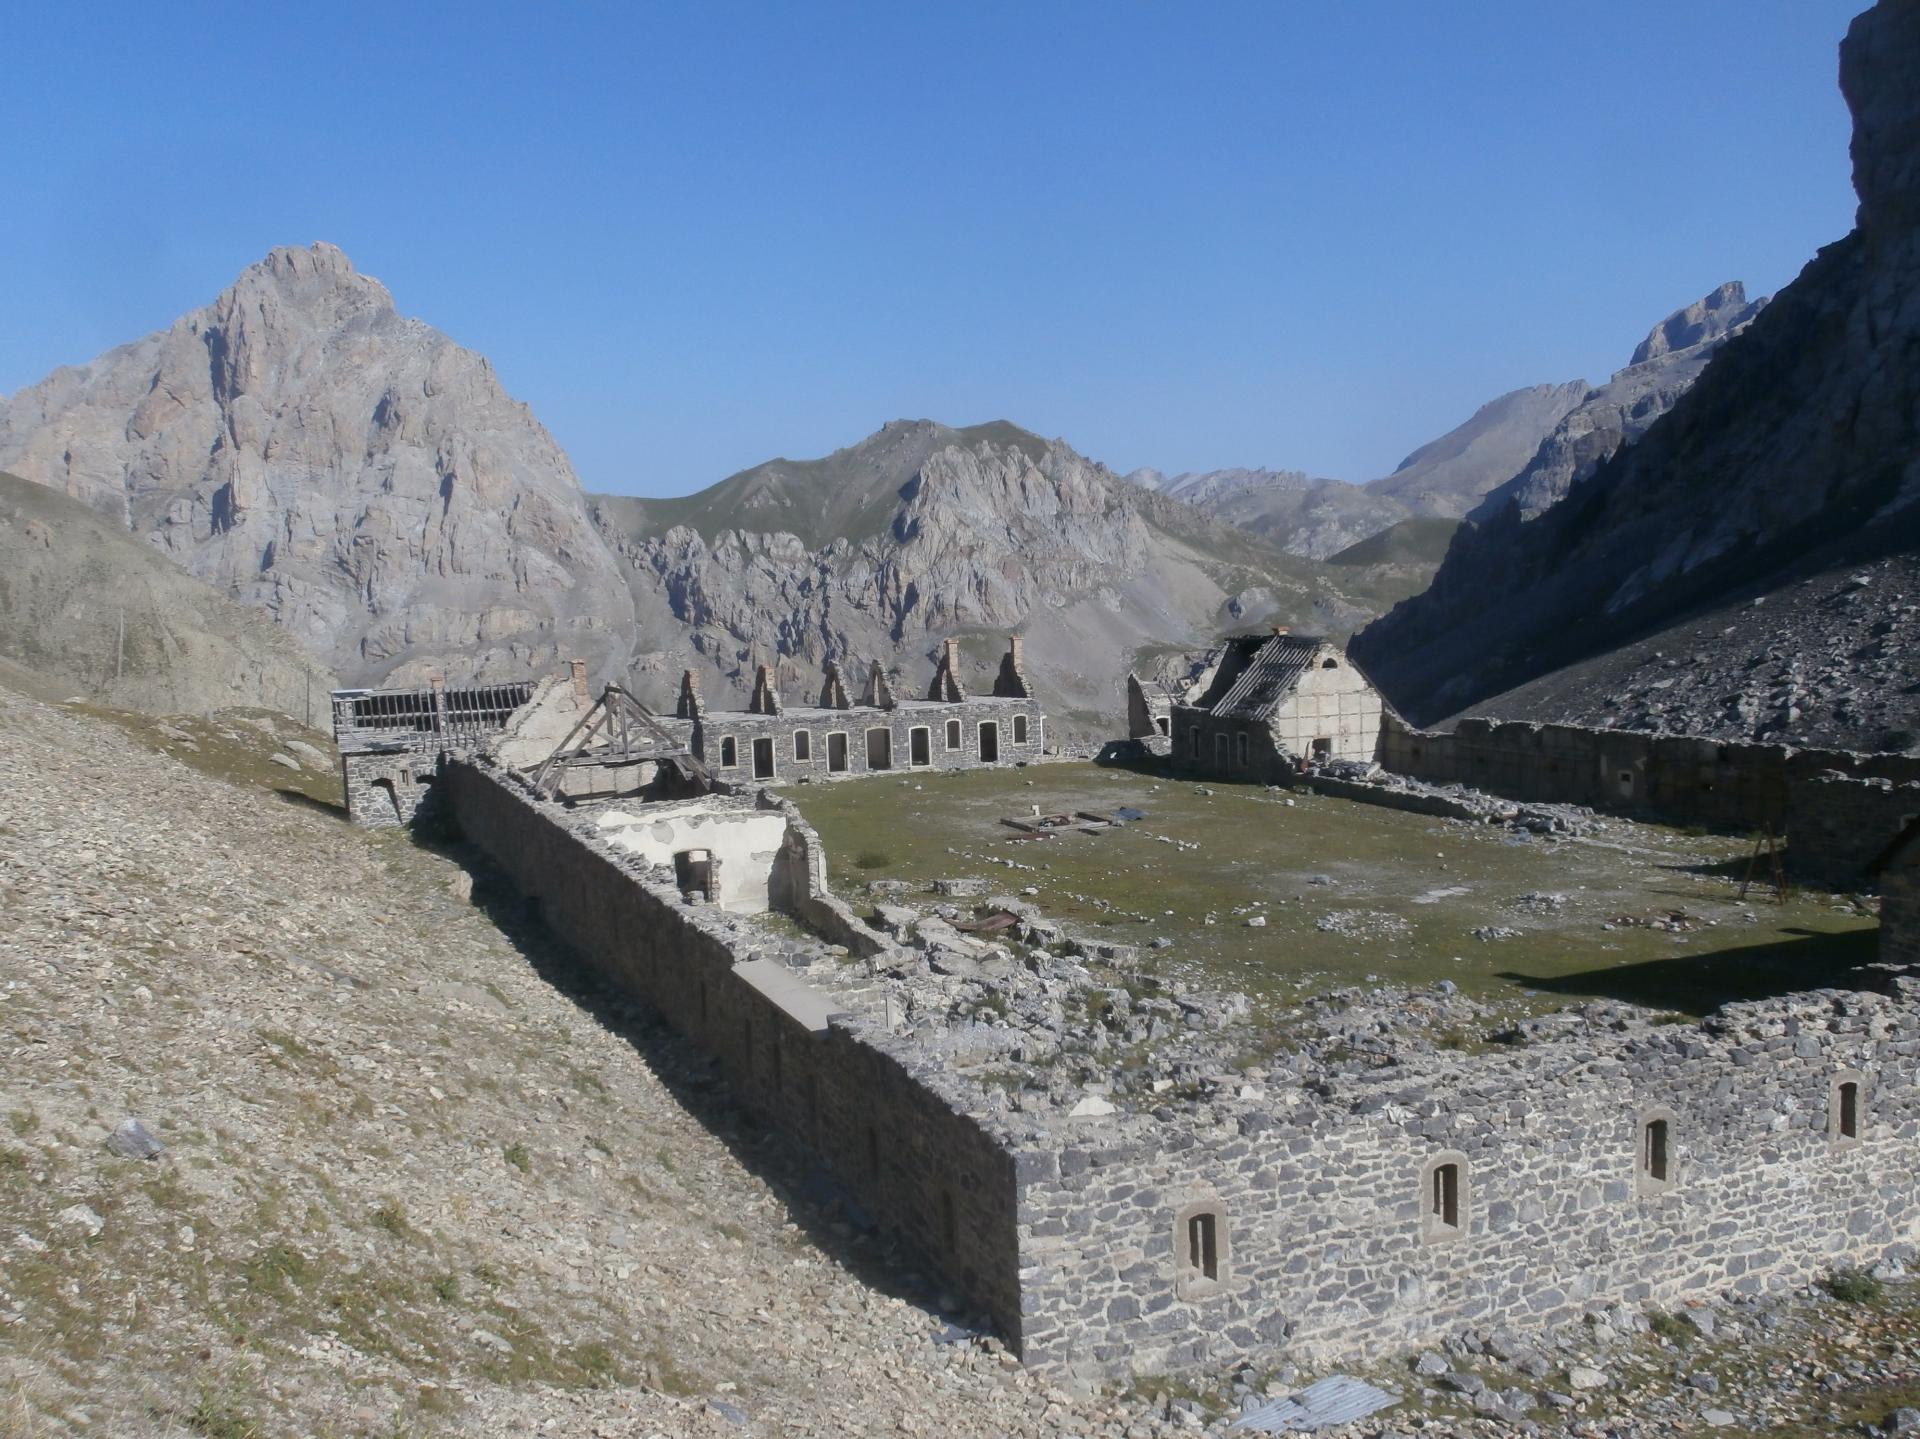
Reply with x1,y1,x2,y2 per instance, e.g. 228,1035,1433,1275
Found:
1500,928,1880,1016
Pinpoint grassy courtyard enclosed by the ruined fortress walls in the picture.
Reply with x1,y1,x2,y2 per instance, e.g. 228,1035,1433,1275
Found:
783,765,1878,1014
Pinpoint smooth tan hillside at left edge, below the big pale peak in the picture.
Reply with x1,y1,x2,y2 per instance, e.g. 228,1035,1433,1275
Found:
0,475,336,724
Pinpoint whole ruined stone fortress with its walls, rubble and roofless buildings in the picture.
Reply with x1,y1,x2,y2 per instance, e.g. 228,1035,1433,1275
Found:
334,636,1920,1379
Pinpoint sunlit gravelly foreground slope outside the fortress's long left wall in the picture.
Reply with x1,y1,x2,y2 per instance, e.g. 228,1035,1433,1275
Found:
0,688,1183,1439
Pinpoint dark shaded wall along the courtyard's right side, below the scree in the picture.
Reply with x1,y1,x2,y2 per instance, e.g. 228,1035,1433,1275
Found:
1379,713,1920,884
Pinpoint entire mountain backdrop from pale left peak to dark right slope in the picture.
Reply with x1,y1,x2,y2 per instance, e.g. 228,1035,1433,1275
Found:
0,6,1920,744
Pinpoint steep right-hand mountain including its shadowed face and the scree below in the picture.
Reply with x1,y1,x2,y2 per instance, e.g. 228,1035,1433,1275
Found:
1354,4,1920,747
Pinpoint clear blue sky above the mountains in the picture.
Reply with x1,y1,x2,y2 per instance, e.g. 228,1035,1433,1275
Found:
0,0,1864,494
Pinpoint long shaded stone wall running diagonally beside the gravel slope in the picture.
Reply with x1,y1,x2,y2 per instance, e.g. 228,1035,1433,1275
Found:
444,759,1021,1345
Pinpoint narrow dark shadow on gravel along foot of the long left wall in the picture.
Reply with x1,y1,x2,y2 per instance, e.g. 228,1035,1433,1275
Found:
417,836,967,1333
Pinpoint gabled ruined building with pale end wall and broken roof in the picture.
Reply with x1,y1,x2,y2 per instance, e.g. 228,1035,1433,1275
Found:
1169,632,1386,784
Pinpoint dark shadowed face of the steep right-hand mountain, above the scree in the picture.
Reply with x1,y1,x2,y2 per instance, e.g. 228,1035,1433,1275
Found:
1354,0,1920,728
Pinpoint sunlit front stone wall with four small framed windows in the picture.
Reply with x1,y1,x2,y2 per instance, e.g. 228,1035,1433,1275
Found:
1020,980,1920,1376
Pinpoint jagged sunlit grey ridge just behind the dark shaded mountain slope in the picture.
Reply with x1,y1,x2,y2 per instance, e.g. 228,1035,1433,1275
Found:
1467,280,1766,523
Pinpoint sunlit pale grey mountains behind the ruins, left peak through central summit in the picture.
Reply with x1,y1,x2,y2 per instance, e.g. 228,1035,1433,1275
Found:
0,244,1432,736
